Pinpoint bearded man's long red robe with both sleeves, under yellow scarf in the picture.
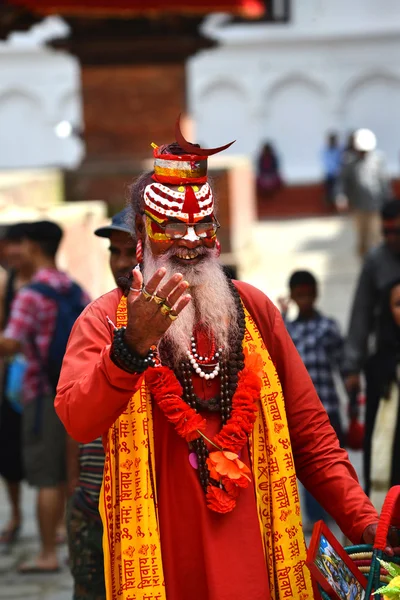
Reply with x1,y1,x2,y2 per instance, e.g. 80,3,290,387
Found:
55,282,378,600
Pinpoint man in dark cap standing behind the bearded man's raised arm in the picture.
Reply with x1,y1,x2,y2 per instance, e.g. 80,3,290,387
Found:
67,208,136,600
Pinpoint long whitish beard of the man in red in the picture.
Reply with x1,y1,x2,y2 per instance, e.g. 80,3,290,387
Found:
143,240,239,366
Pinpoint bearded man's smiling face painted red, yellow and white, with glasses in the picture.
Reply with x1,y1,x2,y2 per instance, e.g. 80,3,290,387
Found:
144,183,219,264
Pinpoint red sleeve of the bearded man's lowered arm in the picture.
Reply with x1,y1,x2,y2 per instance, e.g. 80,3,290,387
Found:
236,282,378,543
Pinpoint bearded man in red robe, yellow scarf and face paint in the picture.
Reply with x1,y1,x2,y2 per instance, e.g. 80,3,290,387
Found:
56,128,384,600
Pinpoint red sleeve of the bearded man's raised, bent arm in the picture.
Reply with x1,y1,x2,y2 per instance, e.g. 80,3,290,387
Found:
55,290,142,443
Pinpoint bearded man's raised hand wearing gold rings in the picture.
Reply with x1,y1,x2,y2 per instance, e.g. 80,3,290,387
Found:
125,268,192,356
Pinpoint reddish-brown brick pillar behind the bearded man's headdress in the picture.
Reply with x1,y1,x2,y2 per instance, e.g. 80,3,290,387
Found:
82,64,185,162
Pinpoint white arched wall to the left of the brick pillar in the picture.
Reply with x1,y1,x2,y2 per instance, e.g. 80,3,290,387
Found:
0,17,84,169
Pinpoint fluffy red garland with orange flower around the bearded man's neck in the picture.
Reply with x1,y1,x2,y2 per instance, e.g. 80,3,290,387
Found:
145,356,261,513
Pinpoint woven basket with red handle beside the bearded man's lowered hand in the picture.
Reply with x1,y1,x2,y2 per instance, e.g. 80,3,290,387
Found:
321,485,400,600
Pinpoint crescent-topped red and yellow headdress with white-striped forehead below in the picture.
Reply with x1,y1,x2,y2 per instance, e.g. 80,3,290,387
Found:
144,117,234,223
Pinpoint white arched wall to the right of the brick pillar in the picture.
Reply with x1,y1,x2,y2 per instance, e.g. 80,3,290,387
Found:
187,0,400,182
